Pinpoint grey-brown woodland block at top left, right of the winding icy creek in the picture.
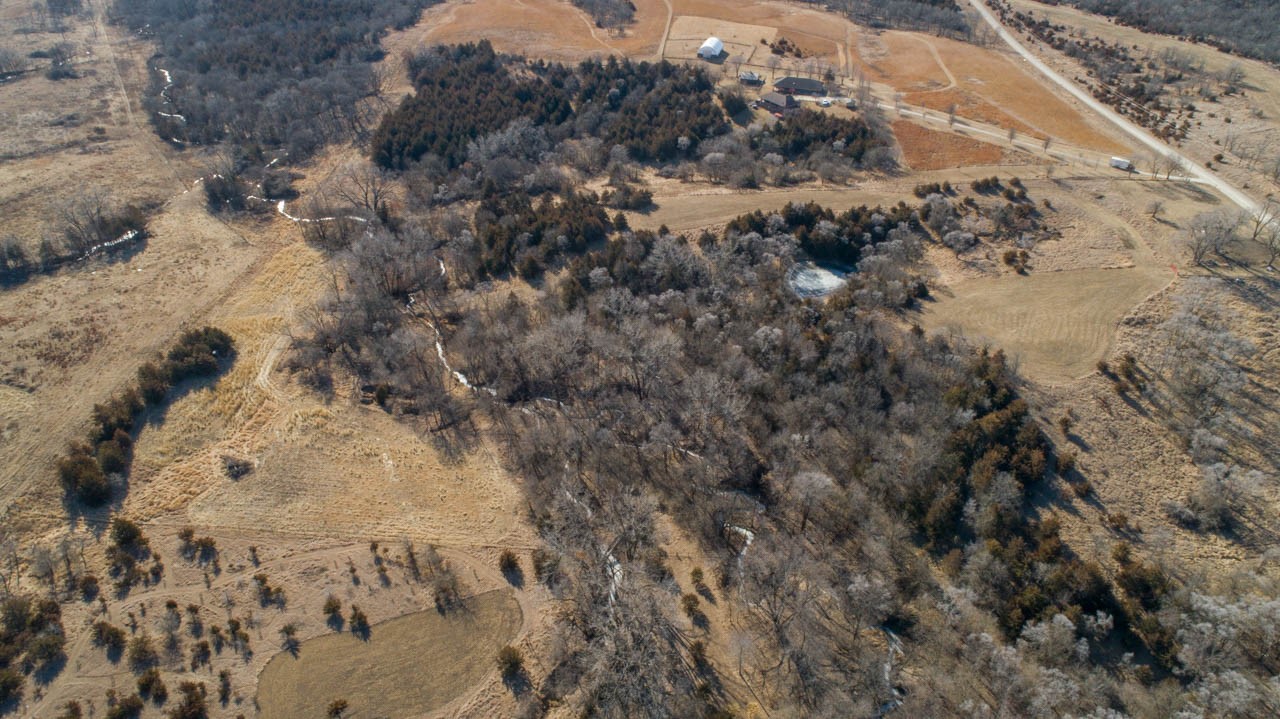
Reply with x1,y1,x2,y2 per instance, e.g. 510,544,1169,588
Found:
113,0,431,160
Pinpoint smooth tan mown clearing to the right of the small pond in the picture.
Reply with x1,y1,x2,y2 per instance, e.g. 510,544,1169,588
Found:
920,269,1169,383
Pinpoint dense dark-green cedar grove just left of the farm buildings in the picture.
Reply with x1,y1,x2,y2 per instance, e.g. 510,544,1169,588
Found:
372,41,728,169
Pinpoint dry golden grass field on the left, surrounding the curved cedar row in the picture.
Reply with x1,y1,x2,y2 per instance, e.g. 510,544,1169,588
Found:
0,0,547,718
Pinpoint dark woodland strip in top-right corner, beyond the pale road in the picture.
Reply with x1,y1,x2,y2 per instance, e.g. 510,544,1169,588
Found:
1041,0,1280,63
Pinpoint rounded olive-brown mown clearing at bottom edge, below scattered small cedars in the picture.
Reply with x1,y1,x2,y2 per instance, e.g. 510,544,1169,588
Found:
257,590,520,719
